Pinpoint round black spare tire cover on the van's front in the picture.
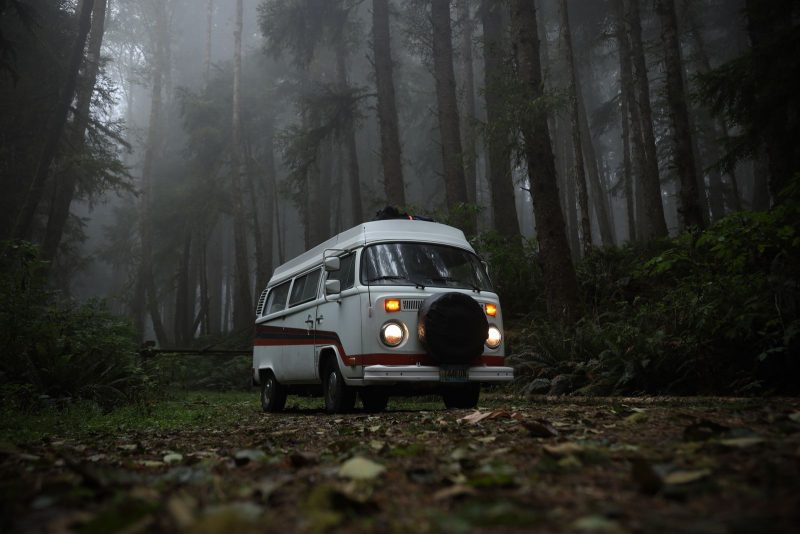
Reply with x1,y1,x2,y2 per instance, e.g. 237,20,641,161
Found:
417,293,489,363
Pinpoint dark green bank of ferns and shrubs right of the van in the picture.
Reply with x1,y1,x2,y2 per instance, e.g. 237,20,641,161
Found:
513,204,800,394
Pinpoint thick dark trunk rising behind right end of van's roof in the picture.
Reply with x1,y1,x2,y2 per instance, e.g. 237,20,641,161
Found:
431,0,467,223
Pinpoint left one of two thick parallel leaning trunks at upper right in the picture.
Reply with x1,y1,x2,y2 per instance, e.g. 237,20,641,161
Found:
624,0,667,239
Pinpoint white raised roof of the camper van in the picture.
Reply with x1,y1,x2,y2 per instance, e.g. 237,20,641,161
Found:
269,219,475,285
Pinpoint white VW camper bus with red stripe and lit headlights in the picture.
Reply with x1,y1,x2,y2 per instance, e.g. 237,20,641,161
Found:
253,219,513,413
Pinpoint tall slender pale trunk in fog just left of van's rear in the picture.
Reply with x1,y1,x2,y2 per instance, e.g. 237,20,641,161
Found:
230,0,253,331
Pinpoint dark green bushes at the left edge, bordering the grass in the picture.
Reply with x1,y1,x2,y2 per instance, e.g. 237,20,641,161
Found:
0,242,146,406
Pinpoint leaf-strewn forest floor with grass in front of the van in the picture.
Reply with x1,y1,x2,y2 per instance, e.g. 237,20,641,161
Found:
0,391,800,534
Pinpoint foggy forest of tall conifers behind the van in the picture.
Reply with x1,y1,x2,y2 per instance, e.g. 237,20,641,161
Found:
0,0,797,345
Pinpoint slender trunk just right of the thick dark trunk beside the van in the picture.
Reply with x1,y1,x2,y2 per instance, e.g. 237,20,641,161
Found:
560,0,592,255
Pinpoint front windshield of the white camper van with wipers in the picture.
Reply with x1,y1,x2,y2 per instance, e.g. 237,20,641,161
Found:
361,243,493,291
